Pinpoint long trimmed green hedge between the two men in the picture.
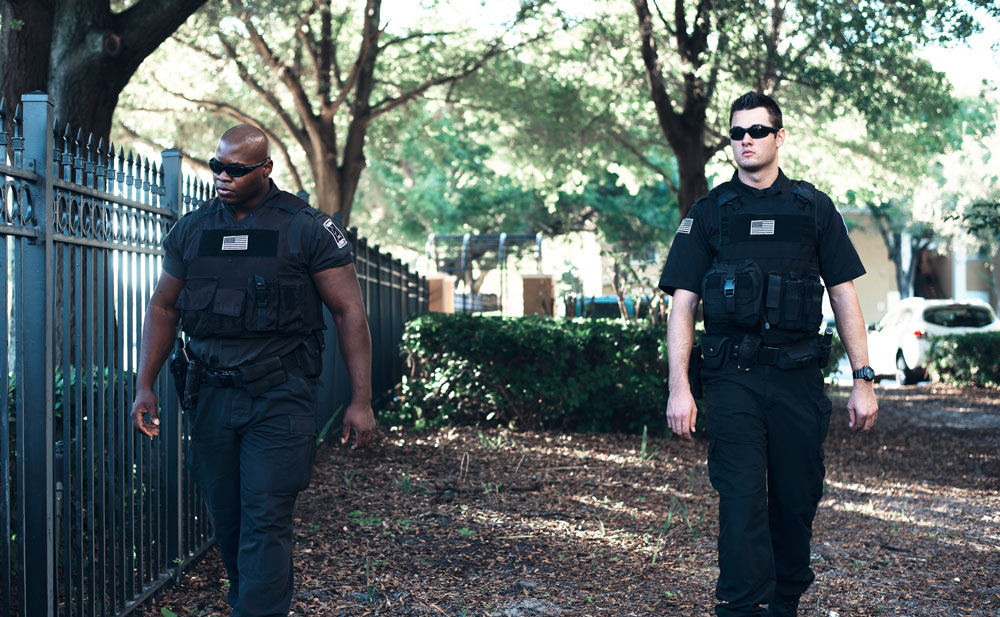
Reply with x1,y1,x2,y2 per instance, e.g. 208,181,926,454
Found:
396,314,667,434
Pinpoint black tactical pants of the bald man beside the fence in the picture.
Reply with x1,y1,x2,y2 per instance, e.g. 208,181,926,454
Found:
189,369,317,617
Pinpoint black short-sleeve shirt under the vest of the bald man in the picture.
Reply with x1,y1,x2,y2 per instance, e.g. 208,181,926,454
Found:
163,180,354,367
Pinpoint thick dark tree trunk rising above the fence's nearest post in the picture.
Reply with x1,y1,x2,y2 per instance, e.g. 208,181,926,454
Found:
0,0,206,138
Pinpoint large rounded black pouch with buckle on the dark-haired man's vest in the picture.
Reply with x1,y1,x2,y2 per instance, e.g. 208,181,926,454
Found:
701,260,764,327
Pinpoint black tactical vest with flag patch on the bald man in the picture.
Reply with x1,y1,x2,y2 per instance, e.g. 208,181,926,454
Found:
174,195,324,338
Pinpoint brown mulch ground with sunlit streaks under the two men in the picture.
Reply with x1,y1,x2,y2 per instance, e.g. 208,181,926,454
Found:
140,386,1000,617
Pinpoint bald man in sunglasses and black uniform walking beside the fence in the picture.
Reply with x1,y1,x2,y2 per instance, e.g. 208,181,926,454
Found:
131,125,375,617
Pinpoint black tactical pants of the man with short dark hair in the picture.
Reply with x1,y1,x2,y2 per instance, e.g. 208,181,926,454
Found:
702,357,831,617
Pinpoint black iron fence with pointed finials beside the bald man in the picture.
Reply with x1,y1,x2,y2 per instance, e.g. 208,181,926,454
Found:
0,93,428,617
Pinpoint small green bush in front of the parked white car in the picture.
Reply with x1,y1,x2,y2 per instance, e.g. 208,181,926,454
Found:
927,332,1000,387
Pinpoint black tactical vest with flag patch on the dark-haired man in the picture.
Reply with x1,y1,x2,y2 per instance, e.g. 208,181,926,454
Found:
702,181,823,342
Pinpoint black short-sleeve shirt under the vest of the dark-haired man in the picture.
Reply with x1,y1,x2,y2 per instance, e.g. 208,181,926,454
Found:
659,171,865,306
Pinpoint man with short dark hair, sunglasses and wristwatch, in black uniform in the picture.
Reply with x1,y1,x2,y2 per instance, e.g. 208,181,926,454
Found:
660,92,878,617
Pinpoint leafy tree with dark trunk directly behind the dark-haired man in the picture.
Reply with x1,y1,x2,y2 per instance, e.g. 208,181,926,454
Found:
633,0,1000,215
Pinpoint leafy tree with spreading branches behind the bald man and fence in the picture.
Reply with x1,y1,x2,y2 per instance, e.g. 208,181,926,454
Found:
134,0,560,222
